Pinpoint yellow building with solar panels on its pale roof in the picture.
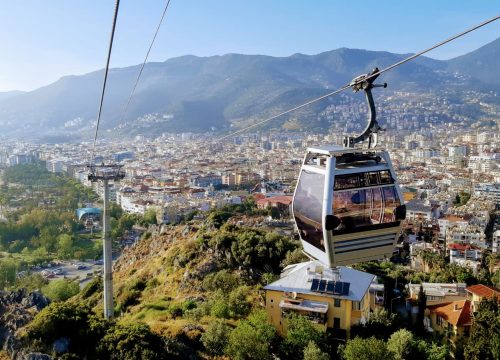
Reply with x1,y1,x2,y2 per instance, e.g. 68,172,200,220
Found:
264,261,375,339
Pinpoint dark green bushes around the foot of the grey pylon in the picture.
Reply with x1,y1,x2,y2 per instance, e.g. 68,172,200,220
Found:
26,302,179,360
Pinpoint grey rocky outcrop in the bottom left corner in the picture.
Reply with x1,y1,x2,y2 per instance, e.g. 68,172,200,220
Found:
0,289,51,360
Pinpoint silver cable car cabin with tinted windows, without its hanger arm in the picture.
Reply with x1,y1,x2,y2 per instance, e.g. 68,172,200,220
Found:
293,147,406,267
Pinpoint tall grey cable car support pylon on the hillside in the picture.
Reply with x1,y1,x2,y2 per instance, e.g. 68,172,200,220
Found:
88,163,125,319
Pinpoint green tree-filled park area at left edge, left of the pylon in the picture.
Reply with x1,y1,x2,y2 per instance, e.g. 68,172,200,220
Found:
0,162,102,289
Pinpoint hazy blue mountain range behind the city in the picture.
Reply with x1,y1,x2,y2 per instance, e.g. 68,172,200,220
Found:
0,38,500,139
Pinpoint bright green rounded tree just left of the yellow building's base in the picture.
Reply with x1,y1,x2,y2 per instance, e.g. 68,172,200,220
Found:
225,311,276,360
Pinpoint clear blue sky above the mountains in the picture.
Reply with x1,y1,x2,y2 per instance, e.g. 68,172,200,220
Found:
0,0,500,91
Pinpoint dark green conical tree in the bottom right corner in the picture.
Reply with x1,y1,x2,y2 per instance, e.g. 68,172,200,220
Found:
464,297,500,360
